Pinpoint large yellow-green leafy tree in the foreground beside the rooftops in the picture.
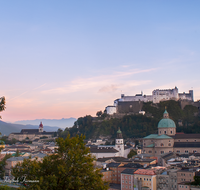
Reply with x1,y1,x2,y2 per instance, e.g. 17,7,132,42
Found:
12,135,108,190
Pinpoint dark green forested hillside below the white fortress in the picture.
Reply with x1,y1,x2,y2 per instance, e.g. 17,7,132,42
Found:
60,100,200,139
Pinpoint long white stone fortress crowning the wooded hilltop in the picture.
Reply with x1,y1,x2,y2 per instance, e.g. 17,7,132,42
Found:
106,87,194,115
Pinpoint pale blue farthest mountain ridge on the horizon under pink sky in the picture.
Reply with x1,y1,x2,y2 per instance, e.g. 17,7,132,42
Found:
15,117,77,129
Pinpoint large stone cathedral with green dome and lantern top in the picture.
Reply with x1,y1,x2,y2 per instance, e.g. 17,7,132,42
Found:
143,110,200,156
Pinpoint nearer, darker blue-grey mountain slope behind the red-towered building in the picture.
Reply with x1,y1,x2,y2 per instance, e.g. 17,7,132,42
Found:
0,121,59,136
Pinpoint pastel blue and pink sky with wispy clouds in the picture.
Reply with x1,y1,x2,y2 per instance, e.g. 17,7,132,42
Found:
0,0,200,122
